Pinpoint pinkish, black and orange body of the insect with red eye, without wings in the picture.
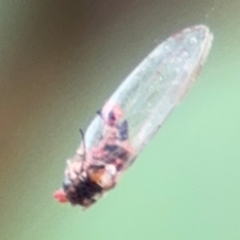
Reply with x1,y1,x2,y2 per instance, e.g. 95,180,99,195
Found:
54,104,133,207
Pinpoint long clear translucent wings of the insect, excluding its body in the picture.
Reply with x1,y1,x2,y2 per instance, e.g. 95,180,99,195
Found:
85,25,213,163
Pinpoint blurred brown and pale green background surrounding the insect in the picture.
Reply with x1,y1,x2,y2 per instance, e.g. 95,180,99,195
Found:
0,0,240,240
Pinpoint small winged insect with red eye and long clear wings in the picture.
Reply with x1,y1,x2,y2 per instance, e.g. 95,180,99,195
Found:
54,25,213,208
